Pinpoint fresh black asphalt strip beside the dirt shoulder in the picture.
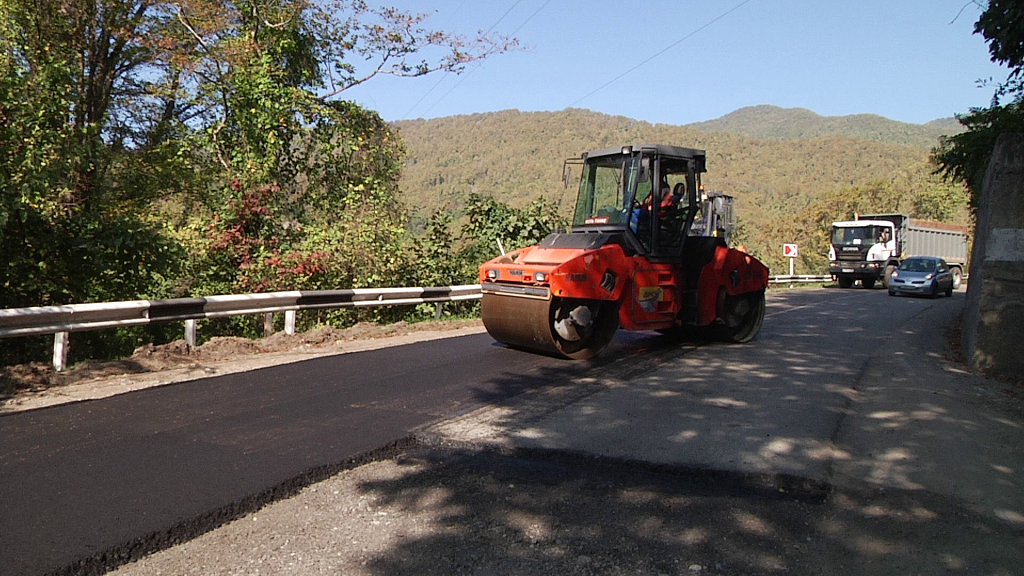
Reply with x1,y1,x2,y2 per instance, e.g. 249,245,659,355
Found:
0,334,632,575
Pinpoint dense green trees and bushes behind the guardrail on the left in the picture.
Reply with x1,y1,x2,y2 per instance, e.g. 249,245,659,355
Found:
0,0,515,362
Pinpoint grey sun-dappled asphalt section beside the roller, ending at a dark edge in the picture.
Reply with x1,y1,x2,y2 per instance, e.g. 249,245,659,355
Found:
445,284,888,482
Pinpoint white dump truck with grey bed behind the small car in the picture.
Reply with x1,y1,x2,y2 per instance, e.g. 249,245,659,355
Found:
828,214,967,288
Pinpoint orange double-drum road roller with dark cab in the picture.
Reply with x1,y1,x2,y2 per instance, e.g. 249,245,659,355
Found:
479,145,768,359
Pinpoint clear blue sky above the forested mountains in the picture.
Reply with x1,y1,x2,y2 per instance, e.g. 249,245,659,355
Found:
341,0,1006,124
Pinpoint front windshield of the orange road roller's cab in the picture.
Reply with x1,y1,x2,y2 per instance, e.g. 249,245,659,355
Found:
572,156,649,227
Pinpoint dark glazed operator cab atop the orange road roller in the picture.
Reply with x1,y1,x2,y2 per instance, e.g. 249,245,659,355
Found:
572,145,706,261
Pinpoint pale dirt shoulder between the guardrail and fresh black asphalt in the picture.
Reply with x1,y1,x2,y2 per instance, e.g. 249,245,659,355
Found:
0,319,484,414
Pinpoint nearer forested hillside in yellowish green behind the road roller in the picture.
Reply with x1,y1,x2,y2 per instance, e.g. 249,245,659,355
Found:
393,109,968,272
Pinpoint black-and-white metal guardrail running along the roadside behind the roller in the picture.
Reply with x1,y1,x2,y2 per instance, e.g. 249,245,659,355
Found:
0,275,831,371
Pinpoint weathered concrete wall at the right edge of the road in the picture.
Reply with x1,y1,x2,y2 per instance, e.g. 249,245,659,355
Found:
963,130,1024,375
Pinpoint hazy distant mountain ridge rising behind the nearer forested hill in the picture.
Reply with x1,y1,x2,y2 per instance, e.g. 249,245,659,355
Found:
688,106,963,148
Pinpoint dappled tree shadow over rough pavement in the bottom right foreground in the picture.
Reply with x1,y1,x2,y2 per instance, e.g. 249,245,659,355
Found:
348,449,1024,575
